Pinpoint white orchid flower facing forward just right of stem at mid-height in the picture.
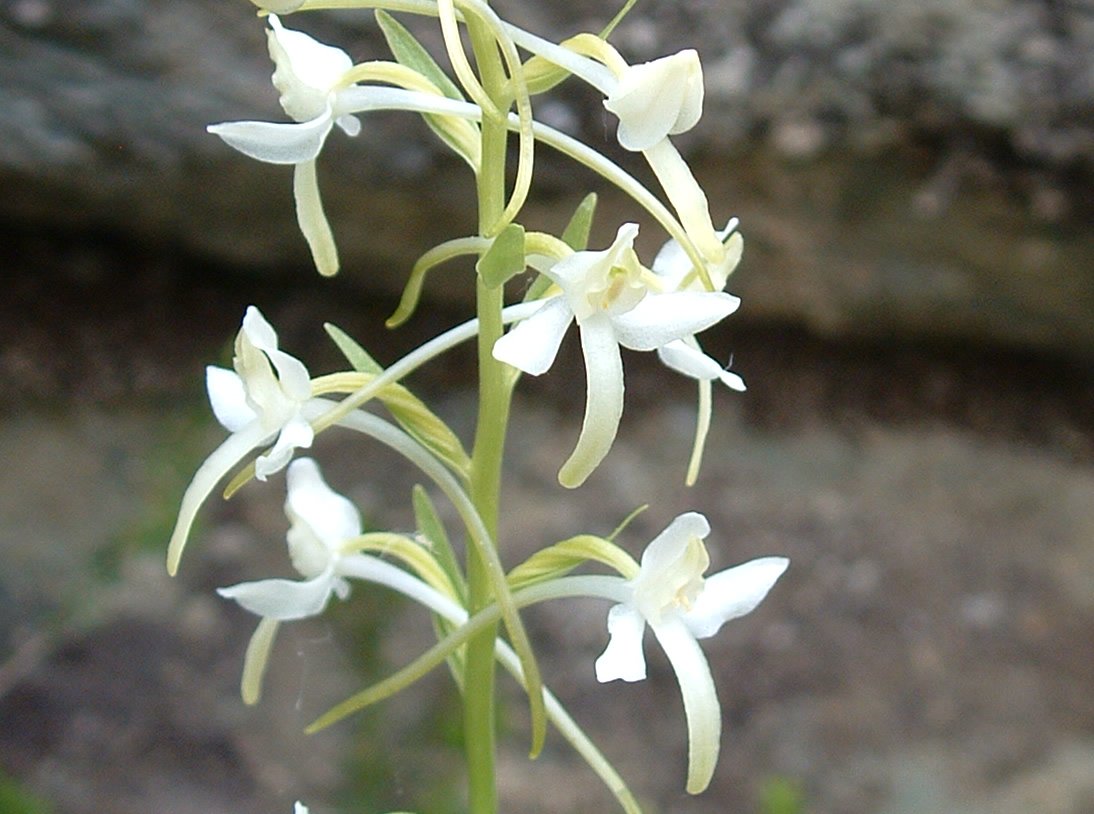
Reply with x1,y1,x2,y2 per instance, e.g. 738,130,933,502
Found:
493,223,741,487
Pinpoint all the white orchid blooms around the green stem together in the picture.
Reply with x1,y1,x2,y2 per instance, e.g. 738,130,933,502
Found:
168,0,788,814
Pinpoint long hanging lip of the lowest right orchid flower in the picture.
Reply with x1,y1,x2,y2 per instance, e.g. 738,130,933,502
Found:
651,619,722,794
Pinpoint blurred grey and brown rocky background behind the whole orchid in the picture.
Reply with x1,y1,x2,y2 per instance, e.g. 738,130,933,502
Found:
0,0,1094,814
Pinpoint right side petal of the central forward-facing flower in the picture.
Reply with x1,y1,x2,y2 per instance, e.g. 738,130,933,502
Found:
612,291,741,350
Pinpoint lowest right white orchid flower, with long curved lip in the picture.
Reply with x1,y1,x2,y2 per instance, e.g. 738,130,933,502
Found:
595,512,790,794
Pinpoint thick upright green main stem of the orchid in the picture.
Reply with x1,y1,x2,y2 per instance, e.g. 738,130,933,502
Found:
464,7,510,814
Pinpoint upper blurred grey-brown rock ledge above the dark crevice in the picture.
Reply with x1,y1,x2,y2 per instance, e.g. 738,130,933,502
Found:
6,0,1094,354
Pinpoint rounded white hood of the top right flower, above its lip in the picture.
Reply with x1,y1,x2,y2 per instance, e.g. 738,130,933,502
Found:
604,49,703,152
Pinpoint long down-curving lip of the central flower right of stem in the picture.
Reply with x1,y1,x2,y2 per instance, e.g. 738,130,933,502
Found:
558,314,624,489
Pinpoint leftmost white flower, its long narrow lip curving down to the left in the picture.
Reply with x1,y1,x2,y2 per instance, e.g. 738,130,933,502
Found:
167,305,314,573
